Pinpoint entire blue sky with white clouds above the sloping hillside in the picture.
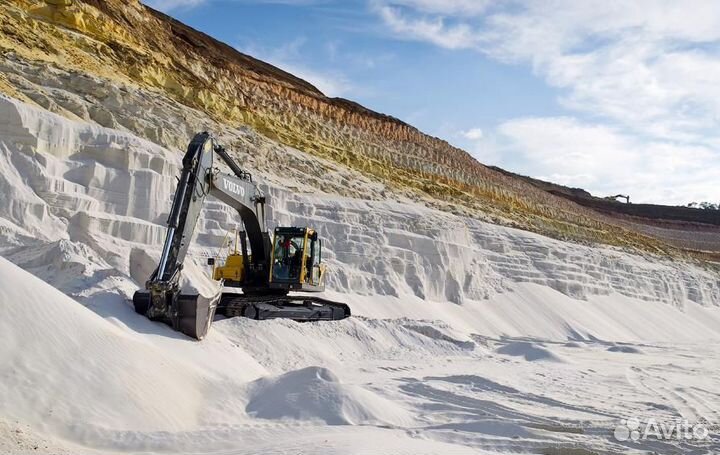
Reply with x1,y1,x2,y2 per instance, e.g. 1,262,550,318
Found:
143,0,720,205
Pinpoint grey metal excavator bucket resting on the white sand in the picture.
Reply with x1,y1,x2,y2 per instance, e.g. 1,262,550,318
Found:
133,291,220,340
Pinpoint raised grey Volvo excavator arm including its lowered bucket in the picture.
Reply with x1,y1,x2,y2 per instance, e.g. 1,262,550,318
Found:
133,133,270,339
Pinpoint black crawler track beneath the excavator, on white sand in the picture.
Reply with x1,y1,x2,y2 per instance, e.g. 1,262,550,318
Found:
217,294,350,322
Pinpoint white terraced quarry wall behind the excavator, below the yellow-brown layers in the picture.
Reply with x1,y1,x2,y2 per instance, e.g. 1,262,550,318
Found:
0,95,720,313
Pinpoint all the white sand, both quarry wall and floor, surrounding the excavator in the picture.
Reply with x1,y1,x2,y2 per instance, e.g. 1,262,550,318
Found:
0,94,720,454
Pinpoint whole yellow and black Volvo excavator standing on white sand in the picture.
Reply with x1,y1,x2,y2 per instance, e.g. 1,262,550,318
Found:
133,132,350,340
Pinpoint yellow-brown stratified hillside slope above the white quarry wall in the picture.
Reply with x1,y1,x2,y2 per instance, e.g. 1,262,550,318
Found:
0,0,720,254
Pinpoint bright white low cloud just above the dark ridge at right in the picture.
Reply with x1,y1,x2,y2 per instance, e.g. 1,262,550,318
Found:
498,117,720,204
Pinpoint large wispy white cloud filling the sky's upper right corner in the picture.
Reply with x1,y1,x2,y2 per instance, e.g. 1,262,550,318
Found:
476,0,720,140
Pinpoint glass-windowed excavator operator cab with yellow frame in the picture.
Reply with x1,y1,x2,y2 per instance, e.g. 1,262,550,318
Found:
269,227,325,292
